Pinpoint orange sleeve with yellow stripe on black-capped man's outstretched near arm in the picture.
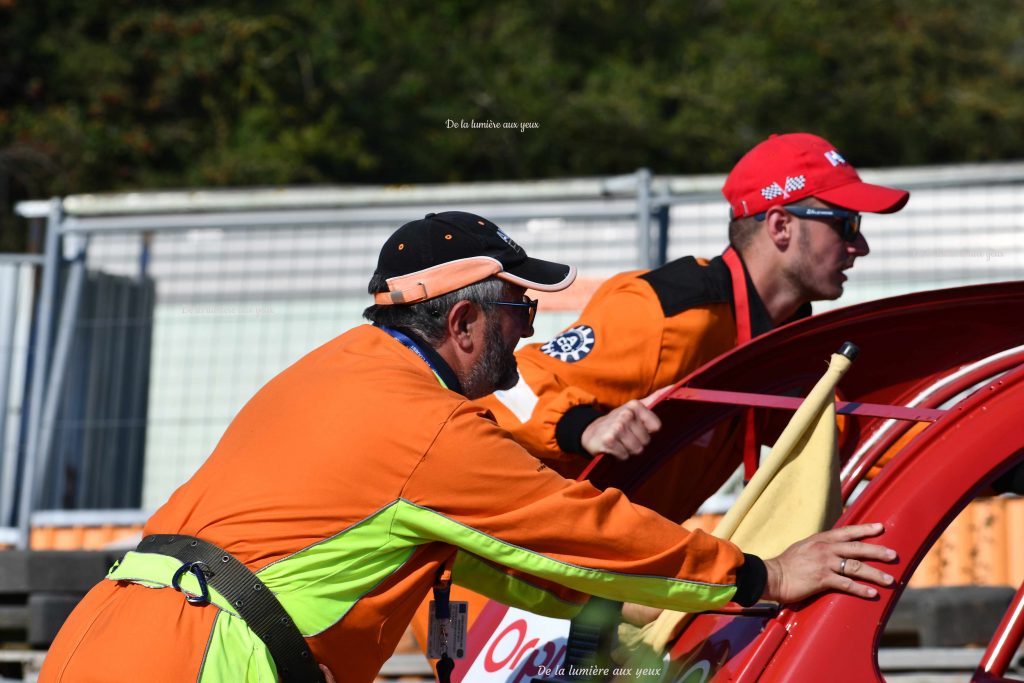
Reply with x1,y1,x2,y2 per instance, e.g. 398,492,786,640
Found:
402,402,760,609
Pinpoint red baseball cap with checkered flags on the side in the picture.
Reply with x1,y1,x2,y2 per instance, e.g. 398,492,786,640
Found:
722,133,910,218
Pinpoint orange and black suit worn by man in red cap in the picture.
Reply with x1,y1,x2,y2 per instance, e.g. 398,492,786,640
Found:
480,255,810,519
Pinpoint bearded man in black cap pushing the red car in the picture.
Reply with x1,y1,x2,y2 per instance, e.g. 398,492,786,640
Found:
40,211,894,682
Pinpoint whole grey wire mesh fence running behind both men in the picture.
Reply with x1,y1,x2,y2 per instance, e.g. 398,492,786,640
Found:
6,165,1024,540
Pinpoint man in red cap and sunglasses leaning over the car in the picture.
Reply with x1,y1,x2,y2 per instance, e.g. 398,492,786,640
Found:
483,133,909,512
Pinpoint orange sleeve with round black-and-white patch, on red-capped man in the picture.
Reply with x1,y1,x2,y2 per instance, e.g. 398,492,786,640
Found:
484,266,736,463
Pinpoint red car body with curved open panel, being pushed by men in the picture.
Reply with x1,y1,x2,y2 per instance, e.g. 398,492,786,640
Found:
455,283,1024,683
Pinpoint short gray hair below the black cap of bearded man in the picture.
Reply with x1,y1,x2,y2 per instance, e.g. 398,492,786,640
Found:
362,272,512,345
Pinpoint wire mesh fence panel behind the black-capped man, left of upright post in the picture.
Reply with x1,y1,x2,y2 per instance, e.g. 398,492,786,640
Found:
39,187,638,518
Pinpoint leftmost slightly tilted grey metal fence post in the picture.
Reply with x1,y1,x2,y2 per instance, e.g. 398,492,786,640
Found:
17,198,63,550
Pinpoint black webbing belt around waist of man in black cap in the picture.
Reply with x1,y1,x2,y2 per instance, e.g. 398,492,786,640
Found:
135,535,324,683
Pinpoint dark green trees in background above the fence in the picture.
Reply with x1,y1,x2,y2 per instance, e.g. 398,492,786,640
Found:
0,0,1024,250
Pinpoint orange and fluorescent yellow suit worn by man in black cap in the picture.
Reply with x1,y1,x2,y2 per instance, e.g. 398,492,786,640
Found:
39,326,765,683
